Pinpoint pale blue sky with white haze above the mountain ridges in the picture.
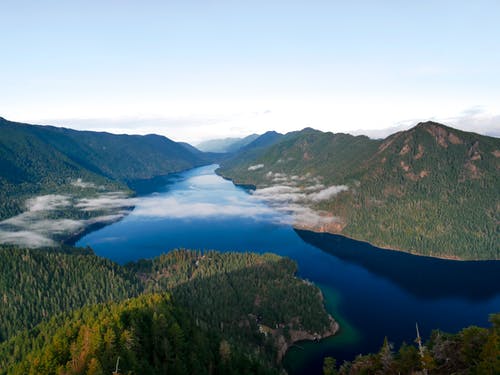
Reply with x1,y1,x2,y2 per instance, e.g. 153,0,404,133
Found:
0,0,500,144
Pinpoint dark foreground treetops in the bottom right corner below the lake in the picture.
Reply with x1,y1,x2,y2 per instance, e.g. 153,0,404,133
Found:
323,314,500,375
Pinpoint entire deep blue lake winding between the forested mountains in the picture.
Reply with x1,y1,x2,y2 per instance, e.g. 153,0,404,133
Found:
77,166,500,374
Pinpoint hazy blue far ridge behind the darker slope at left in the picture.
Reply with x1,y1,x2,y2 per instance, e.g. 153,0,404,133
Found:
0,120,206,181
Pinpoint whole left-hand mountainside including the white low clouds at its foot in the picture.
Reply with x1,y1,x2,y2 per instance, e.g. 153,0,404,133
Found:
0,118,213,246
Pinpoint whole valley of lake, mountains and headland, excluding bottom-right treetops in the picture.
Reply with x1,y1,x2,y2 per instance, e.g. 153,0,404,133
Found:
0,120,500,374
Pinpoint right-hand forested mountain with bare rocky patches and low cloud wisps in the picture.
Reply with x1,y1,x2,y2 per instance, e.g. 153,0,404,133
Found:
219,122,500,259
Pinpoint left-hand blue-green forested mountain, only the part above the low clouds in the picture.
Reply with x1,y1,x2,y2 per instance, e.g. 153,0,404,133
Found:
0,118,208,219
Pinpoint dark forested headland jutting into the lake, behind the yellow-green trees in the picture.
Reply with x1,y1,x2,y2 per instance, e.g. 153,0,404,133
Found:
127,251,338,361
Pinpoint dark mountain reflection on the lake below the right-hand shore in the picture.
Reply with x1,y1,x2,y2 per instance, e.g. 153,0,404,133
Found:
296,230,500,301
